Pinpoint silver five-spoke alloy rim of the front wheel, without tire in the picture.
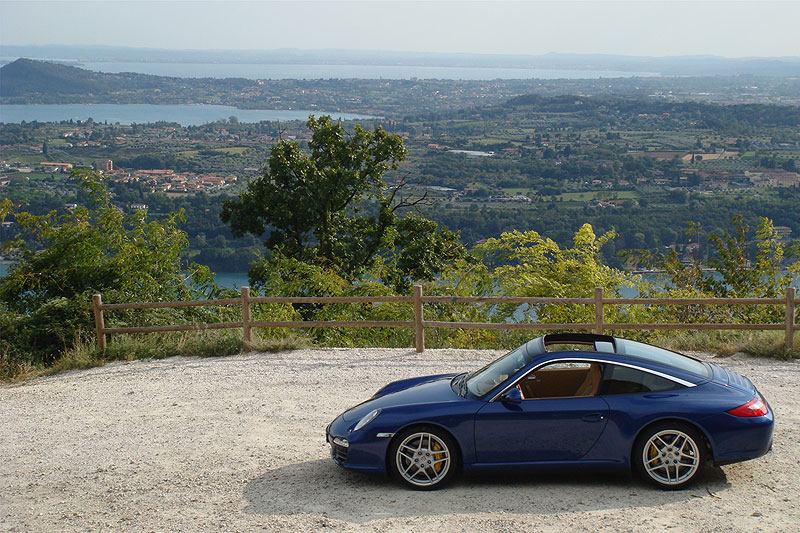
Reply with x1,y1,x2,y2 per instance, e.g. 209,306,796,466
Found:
395,432,450,487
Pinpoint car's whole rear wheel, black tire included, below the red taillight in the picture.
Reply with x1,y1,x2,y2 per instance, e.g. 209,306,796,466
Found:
631,421,707,490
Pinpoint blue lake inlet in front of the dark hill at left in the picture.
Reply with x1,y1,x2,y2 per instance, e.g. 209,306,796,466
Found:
0,104,374,126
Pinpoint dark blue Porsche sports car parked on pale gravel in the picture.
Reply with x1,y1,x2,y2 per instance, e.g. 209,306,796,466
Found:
326,334,774,489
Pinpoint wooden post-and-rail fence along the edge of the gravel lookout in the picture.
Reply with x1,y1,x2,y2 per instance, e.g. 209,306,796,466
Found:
92,285,800,352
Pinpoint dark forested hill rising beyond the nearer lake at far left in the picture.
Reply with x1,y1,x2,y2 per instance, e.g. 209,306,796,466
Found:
0,58,255,98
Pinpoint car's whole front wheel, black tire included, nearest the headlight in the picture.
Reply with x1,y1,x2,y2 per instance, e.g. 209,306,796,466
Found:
386,426,461,490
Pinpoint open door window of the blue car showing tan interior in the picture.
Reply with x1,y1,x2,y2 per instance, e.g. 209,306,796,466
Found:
517,361,603,400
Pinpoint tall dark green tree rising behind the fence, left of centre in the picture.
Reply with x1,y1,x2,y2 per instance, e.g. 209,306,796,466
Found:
220,115,463,286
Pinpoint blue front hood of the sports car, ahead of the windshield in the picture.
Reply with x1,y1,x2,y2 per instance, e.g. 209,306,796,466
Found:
342,374,463,422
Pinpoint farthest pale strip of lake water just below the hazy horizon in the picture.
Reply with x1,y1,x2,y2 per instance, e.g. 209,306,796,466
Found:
73,58,660,80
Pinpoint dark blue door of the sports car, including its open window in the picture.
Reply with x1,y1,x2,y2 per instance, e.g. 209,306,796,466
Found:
475,361,609,463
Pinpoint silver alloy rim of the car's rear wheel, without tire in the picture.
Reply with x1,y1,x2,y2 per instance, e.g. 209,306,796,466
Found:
642,429,700,485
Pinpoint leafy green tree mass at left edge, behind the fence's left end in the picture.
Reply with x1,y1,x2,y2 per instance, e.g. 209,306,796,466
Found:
0,172,215,373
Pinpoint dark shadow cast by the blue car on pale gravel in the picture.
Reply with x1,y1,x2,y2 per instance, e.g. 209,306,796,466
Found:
244,459,729,523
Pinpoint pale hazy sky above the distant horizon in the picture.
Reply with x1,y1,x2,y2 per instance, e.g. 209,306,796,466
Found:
0,0,800,57
